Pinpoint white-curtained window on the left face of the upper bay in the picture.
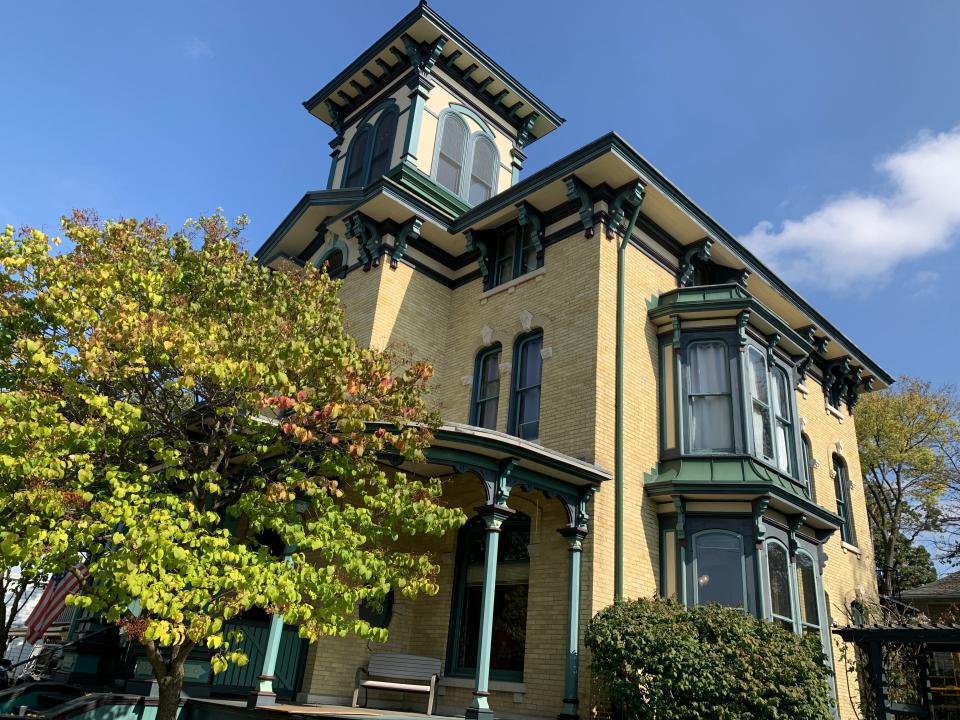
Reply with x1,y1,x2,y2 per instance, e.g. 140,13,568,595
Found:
687,341,733,451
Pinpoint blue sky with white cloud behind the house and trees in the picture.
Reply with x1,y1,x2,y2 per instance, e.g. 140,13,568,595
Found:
0,0,960,394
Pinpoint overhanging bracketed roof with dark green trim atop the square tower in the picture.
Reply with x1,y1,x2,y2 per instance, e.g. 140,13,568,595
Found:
303,1,563,142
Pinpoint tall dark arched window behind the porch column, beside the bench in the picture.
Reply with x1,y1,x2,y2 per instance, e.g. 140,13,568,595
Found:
448,512,530,680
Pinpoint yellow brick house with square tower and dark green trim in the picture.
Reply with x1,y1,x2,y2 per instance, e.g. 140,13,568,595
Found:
257,3,892,718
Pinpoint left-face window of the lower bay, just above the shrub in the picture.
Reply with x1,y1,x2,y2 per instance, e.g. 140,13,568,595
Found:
693,530,747,609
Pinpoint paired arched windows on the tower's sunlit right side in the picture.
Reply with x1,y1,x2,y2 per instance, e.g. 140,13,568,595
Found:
433,110,499,205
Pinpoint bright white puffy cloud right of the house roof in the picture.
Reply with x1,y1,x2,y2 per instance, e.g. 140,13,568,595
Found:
741,126,960,292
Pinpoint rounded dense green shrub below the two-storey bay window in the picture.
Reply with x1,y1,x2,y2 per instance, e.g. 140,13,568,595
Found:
585,598,833,720
